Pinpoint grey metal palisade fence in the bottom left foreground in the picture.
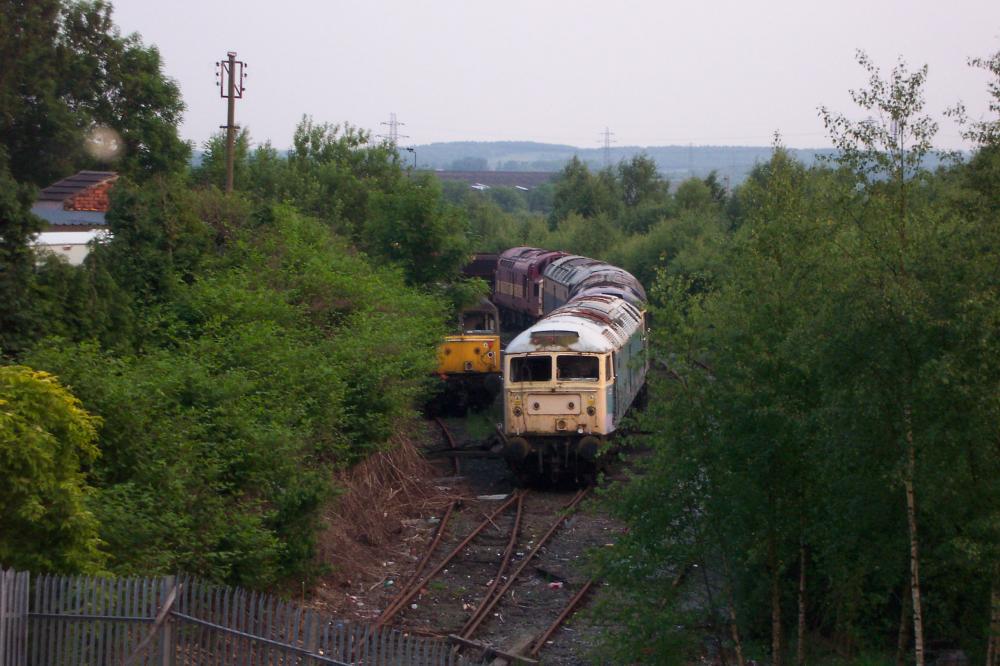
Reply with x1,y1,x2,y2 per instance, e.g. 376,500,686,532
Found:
0,570,467,666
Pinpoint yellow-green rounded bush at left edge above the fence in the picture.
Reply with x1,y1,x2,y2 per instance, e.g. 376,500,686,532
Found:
0,366,103,573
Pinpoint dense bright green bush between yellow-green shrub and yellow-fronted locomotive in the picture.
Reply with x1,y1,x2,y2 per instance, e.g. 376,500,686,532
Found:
22,206,444,586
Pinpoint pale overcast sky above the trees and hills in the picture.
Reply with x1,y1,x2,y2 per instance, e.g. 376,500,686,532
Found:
112,0,1000,148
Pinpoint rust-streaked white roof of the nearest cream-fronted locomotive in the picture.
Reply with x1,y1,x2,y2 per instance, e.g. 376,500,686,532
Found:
505,294,642,354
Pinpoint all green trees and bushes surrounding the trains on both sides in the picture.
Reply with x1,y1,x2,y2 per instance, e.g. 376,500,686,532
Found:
0,2,1000,664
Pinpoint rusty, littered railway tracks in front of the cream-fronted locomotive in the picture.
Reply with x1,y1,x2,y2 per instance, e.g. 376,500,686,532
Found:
376,419,621,664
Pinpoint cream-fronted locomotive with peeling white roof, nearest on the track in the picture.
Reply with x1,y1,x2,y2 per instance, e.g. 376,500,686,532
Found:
503,294,648,482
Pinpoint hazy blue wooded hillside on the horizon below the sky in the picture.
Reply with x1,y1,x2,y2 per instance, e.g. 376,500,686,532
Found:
404,141,832,184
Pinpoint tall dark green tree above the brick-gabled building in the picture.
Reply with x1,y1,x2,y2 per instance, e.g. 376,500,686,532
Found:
0,0,190,186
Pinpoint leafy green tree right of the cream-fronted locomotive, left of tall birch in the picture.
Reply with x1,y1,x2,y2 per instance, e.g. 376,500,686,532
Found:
592,149,825,664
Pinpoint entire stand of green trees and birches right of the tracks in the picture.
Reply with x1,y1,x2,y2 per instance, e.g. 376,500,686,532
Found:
588,55,1000,664
